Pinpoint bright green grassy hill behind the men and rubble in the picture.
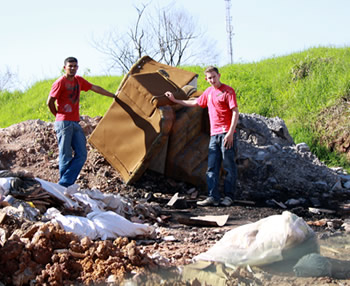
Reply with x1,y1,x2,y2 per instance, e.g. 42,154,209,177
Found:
0,48,350,170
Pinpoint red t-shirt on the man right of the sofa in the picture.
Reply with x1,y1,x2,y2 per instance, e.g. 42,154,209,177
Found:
197,84,238,136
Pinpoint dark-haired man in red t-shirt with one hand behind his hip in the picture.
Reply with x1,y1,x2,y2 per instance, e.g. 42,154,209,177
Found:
47,57,115,187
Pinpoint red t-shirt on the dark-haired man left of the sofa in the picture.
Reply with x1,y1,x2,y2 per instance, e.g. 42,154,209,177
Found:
50,75,92,121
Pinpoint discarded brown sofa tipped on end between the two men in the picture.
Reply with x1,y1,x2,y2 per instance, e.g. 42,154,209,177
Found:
88,56,209,186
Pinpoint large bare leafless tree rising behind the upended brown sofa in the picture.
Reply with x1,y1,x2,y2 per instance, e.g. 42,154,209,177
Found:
93,2,217,73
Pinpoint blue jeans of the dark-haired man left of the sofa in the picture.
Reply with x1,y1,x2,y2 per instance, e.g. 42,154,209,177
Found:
55,121,87,187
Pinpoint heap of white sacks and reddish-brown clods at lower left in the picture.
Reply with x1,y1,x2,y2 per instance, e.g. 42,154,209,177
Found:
0,171,157,285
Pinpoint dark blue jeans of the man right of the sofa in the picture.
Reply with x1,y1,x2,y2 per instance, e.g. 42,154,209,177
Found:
206,133,237,201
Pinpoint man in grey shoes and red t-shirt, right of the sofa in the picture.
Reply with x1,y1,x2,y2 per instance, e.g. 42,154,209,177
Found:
165,66,239,206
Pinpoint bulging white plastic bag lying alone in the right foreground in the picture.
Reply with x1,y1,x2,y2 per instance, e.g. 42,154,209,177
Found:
194,211,315,265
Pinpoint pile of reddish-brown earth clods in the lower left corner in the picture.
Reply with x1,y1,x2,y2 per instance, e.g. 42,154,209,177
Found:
0,223,156,285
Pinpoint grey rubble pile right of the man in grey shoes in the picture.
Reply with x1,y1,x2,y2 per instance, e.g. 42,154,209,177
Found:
237,114,350,209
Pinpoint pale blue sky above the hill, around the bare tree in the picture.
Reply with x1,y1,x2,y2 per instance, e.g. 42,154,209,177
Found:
0,0,350,88
